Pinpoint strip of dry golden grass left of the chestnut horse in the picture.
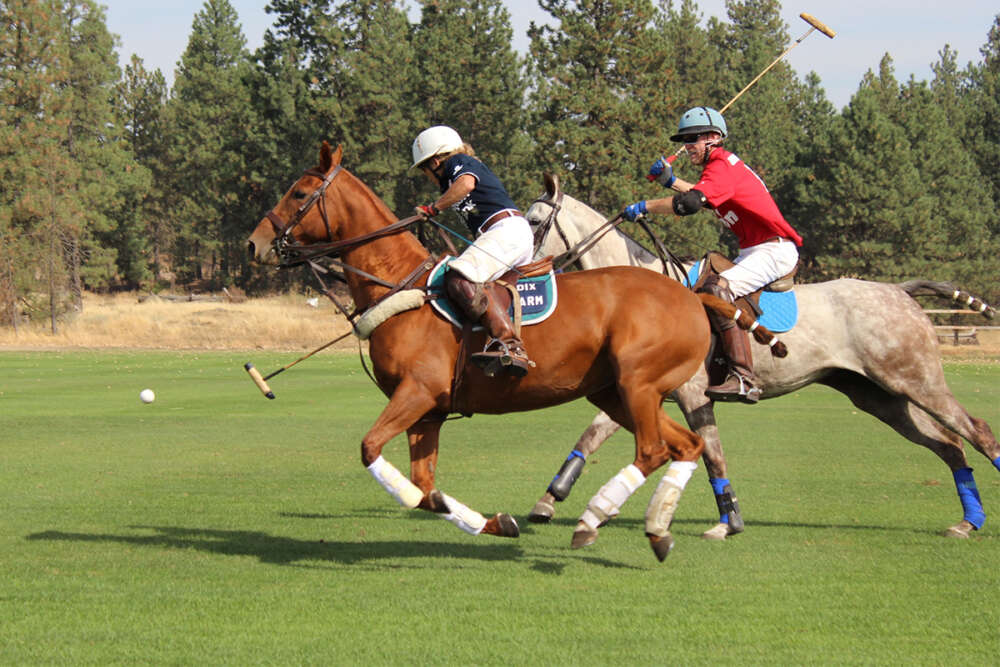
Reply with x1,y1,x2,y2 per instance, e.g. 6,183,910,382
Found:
0,293,357,350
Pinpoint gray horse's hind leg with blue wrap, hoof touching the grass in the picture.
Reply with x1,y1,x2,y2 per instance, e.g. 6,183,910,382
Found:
822,372,996,537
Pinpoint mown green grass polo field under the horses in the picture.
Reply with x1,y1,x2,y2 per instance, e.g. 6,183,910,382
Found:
0,352,1000,665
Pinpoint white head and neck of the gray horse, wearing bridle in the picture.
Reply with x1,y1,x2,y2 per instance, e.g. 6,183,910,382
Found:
525,173,677,278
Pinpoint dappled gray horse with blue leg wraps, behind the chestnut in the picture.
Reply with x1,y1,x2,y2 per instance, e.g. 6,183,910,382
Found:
526,174,1000,539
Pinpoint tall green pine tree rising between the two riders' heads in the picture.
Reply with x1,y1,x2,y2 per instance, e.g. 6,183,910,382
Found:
529,0,665,219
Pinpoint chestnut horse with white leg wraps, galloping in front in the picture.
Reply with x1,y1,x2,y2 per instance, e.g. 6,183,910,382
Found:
249,142,784,560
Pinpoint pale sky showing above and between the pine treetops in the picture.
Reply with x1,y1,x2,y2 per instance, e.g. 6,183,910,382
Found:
100,0,1000,108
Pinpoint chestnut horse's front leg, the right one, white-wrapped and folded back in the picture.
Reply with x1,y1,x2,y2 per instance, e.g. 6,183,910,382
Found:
407,416,520,537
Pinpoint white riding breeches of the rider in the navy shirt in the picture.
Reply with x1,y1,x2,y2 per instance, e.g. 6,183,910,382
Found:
448,215,535,283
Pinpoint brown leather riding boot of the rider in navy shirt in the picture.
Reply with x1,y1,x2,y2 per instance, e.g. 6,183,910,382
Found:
445,271,535,377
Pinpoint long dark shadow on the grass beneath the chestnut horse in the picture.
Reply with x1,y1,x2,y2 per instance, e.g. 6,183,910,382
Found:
25,515,636,575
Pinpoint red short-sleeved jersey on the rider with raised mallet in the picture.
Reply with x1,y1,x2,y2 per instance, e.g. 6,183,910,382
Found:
694,147,802,248
